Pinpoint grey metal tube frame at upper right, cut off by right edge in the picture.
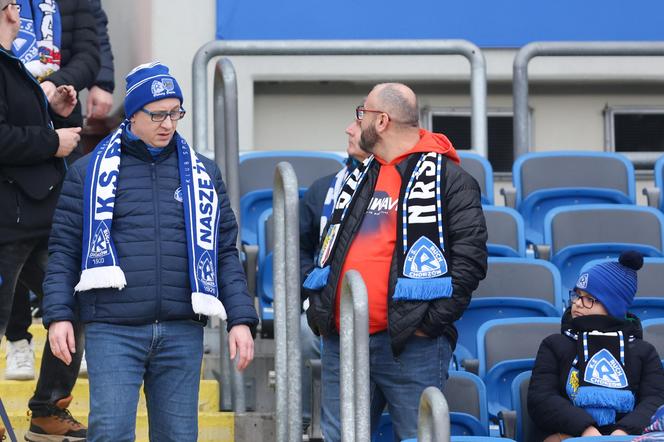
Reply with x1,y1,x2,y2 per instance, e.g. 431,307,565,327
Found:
512,41,664,159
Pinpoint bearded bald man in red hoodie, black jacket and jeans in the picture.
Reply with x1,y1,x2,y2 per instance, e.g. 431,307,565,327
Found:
304,83,487,441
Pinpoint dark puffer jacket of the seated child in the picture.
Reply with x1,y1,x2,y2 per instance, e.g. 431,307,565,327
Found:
528,309,664,436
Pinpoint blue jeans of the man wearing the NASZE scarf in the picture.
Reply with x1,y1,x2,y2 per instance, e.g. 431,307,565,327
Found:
85,322,203,442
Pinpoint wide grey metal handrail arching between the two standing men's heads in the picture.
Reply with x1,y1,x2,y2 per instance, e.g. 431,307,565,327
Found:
192,40,487,158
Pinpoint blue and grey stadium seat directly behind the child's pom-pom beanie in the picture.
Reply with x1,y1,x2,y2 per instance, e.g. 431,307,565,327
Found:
579,258,664,321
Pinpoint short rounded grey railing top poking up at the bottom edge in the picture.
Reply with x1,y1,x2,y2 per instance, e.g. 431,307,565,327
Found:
417,387,450,442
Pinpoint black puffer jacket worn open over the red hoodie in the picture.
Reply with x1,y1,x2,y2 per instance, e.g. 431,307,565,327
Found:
307,154,487,355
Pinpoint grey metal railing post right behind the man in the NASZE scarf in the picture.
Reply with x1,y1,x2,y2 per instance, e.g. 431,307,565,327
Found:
213,58,247,413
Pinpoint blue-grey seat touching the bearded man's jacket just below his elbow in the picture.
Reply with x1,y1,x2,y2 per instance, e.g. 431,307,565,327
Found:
454,257,563,362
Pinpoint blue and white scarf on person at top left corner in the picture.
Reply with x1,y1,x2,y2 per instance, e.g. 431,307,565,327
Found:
12,0,62,81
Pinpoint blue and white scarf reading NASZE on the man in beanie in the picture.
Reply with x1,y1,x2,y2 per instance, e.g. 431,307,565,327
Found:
75,121,226,319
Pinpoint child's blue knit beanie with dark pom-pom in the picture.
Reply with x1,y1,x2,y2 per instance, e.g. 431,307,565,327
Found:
576,250,643,319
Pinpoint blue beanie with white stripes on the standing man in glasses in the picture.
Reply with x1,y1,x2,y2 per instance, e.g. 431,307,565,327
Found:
124,61,184,118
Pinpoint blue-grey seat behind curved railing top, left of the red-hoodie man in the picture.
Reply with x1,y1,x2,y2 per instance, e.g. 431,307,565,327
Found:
239,151,344,244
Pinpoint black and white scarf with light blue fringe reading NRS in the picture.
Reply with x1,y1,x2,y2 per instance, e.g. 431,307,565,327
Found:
304,152,452,301
